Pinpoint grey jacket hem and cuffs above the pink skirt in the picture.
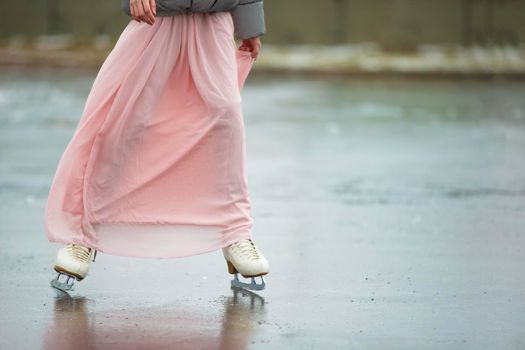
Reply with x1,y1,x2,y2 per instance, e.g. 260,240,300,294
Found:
121,0,266,39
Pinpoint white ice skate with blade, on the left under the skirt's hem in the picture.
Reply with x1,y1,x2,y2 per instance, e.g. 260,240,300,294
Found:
51,244,97,293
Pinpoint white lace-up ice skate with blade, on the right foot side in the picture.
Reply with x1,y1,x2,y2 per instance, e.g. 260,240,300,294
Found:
222,239,269,290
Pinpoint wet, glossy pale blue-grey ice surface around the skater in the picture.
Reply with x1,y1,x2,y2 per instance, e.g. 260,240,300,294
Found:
0,69,525,350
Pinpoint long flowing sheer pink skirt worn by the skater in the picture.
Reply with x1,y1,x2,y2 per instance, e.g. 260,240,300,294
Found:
45,12,253,258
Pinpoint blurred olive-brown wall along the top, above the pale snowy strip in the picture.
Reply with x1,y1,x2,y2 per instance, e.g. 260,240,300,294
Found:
0,0,525,50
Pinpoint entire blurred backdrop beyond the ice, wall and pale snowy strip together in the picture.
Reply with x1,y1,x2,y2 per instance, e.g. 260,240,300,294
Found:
0,0,525,75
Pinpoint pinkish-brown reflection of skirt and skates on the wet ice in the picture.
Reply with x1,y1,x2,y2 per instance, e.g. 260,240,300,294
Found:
42,287,265,350
